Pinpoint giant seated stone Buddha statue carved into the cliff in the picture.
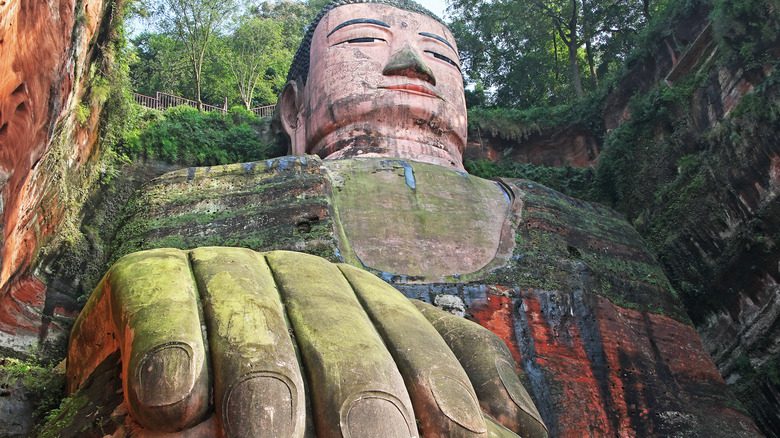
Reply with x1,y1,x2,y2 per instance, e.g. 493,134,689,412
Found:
59,0,754,438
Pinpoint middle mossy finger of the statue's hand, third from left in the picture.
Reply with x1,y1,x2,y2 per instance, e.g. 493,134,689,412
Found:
266,251,419,438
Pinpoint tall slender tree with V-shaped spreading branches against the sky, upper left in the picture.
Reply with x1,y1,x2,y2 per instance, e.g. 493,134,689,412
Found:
155,0,236,103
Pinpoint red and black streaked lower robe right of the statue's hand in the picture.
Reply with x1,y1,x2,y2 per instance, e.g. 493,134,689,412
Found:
469,289,760,437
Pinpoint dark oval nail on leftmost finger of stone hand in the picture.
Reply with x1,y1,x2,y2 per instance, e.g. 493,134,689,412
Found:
136,345,195,407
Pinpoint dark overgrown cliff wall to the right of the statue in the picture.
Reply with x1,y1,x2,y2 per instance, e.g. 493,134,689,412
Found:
466,1,780,436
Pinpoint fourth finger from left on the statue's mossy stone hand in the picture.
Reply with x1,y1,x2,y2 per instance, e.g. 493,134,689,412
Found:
339,265,487,438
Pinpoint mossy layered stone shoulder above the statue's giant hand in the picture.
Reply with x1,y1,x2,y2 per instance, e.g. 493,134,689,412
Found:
112,157,337,261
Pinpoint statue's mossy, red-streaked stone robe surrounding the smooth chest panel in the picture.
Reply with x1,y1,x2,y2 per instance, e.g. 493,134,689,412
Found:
82,157,759,437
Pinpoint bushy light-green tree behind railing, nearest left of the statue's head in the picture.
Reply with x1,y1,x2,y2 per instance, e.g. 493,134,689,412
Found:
228,17,292,109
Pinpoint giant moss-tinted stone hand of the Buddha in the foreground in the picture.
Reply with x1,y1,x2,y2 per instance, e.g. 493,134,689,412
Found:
67,248,547,437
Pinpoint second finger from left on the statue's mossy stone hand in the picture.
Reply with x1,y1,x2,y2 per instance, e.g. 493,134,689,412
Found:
190,248,306,438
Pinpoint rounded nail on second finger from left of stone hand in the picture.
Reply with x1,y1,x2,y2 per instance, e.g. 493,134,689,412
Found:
227,375,305,438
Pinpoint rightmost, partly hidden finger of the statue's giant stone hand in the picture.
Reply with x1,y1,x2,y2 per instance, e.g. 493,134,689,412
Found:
412,300,548,438
